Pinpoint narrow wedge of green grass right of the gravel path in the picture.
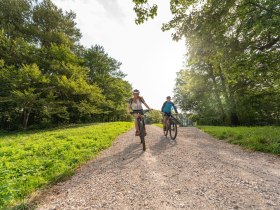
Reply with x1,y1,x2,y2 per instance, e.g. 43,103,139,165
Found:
198,126,280,154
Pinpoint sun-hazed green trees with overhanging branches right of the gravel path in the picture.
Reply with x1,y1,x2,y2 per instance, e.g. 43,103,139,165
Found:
132,0,280,125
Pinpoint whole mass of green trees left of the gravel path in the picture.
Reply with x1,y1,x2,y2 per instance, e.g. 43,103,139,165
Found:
0,0,131,130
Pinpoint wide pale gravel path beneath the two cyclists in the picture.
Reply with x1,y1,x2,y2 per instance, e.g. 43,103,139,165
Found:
37,126,280,210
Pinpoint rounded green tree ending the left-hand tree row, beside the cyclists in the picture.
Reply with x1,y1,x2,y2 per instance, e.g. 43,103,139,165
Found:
82,45,132,121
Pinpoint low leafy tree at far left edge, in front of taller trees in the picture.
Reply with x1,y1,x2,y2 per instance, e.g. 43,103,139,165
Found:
0,62,48,129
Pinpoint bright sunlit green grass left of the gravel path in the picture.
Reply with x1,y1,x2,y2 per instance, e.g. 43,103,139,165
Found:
0,122,133,209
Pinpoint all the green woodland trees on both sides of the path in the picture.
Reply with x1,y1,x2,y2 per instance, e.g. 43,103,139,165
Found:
0,0,280,130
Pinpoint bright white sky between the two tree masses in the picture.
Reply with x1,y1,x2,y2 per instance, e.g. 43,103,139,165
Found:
53,0,186,109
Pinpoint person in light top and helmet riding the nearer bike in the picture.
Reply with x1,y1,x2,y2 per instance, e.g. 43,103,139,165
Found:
127,89,151,136
